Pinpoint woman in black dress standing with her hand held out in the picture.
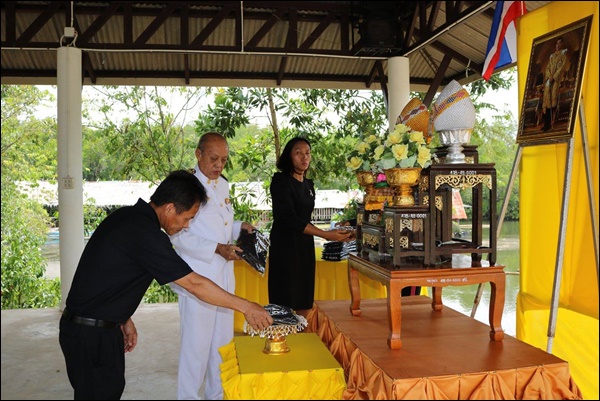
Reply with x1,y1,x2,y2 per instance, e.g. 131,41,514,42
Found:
268,137,351,317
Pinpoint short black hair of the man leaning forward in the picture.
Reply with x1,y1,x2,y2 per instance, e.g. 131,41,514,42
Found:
150,170,208,214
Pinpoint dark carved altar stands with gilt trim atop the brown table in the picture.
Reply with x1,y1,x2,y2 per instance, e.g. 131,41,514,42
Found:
357,159,498,267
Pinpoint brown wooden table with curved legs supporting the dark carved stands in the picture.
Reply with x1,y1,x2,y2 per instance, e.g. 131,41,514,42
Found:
348,253,506,349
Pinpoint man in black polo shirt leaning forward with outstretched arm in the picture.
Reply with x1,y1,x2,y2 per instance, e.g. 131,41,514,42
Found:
59,170,273,400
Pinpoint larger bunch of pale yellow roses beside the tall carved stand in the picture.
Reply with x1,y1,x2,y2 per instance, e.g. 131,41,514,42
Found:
373,123,435,171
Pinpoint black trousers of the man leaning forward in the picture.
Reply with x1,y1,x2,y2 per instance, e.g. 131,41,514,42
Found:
58,318,125,400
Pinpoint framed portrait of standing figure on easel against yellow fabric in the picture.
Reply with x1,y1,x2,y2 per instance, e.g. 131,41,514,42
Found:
517,16,592,144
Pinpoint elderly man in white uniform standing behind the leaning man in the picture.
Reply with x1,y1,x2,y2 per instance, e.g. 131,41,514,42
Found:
171,132,254,400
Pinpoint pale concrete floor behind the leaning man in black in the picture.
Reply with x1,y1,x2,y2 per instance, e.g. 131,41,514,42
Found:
1,303,179,400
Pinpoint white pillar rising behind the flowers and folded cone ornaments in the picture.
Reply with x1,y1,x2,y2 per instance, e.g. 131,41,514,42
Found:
388,57,410,129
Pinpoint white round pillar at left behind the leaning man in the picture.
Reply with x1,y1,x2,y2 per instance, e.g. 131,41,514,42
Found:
56,47,84,310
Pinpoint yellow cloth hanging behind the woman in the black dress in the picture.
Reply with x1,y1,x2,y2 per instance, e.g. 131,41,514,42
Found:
234,248,387,332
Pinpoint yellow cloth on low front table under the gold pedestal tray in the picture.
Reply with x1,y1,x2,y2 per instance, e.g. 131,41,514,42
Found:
219,333,346,400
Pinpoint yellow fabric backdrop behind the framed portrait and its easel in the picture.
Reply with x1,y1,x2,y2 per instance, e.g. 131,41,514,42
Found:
517,1,599,399
